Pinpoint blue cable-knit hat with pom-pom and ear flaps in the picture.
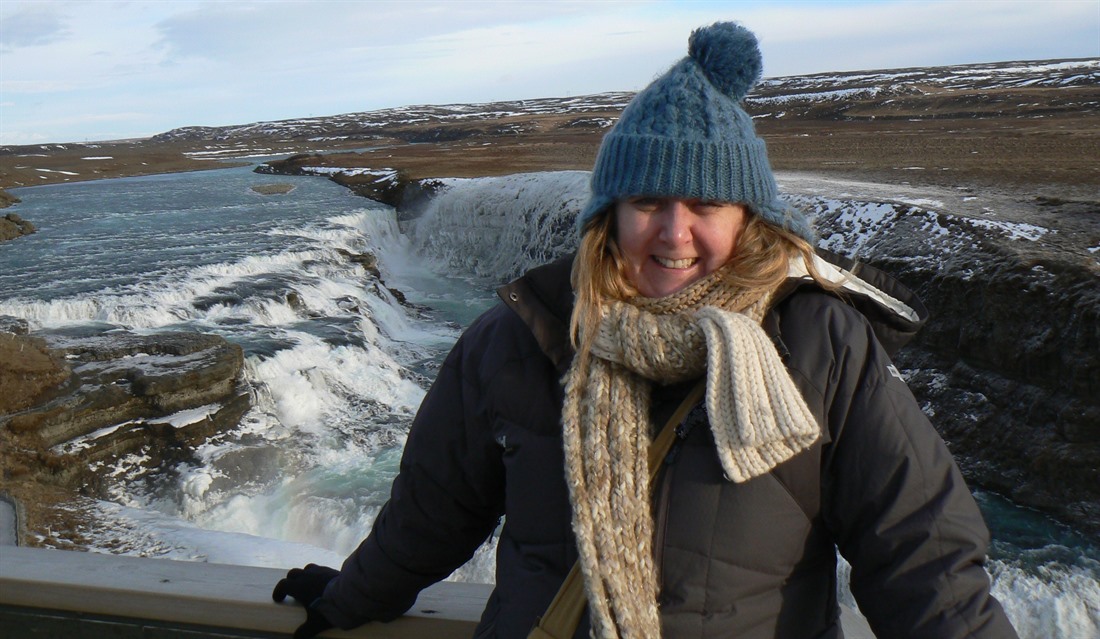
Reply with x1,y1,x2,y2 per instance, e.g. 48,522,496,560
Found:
578,22,814,243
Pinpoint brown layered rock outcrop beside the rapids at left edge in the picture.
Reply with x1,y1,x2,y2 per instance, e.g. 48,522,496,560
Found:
0,327,250,495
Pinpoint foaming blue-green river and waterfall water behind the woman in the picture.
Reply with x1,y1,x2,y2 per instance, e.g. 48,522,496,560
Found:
0,162,1100,639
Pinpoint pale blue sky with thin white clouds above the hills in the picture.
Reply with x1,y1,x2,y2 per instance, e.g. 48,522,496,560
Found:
0,0,1100,144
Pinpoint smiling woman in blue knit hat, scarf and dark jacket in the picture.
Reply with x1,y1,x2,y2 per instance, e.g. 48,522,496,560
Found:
274,23,1015,639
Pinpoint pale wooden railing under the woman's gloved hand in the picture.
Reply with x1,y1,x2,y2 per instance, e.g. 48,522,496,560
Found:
0,547,492,639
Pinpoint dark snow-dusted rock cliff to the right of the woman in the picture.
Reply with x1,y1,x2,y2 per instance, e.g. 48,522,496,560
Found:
817,196,1100,530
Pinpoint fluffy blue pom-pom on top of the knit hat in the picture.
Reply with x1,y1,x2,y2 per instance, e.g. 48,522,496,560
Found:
688,22,763,102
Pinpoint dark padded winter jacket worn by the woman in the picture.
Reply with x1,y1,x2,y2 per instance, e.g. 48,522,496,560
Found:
318,251,1015,639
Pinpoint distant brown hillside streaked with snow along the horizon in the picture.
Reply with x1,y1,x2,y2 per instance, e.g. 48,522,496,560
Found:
0,58,1100,196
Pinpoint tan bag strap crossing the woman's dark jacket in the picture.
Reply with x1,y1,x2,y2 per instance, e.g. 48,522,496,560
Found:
527,378,706,639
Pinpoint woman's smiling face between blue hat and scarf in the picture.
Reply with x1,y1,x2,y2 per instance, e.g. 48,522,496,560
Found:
615,197,747,297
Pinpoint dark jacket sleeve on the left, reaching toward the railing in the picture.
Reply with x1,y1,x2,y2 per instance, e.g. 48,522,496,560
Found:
314,311,504,629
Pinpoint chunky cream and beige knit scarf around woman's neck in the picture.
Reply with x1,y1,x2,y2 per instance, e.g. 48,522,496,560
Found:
562,266,820,639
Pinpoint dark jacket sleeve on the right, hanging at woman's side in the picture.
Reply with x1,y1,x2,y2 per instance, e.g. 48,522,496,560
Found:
820,302,1016,639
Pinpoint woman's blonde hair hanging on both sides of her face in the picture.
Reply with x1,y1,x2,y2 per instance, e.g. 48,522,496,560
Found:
569,205,836,364
